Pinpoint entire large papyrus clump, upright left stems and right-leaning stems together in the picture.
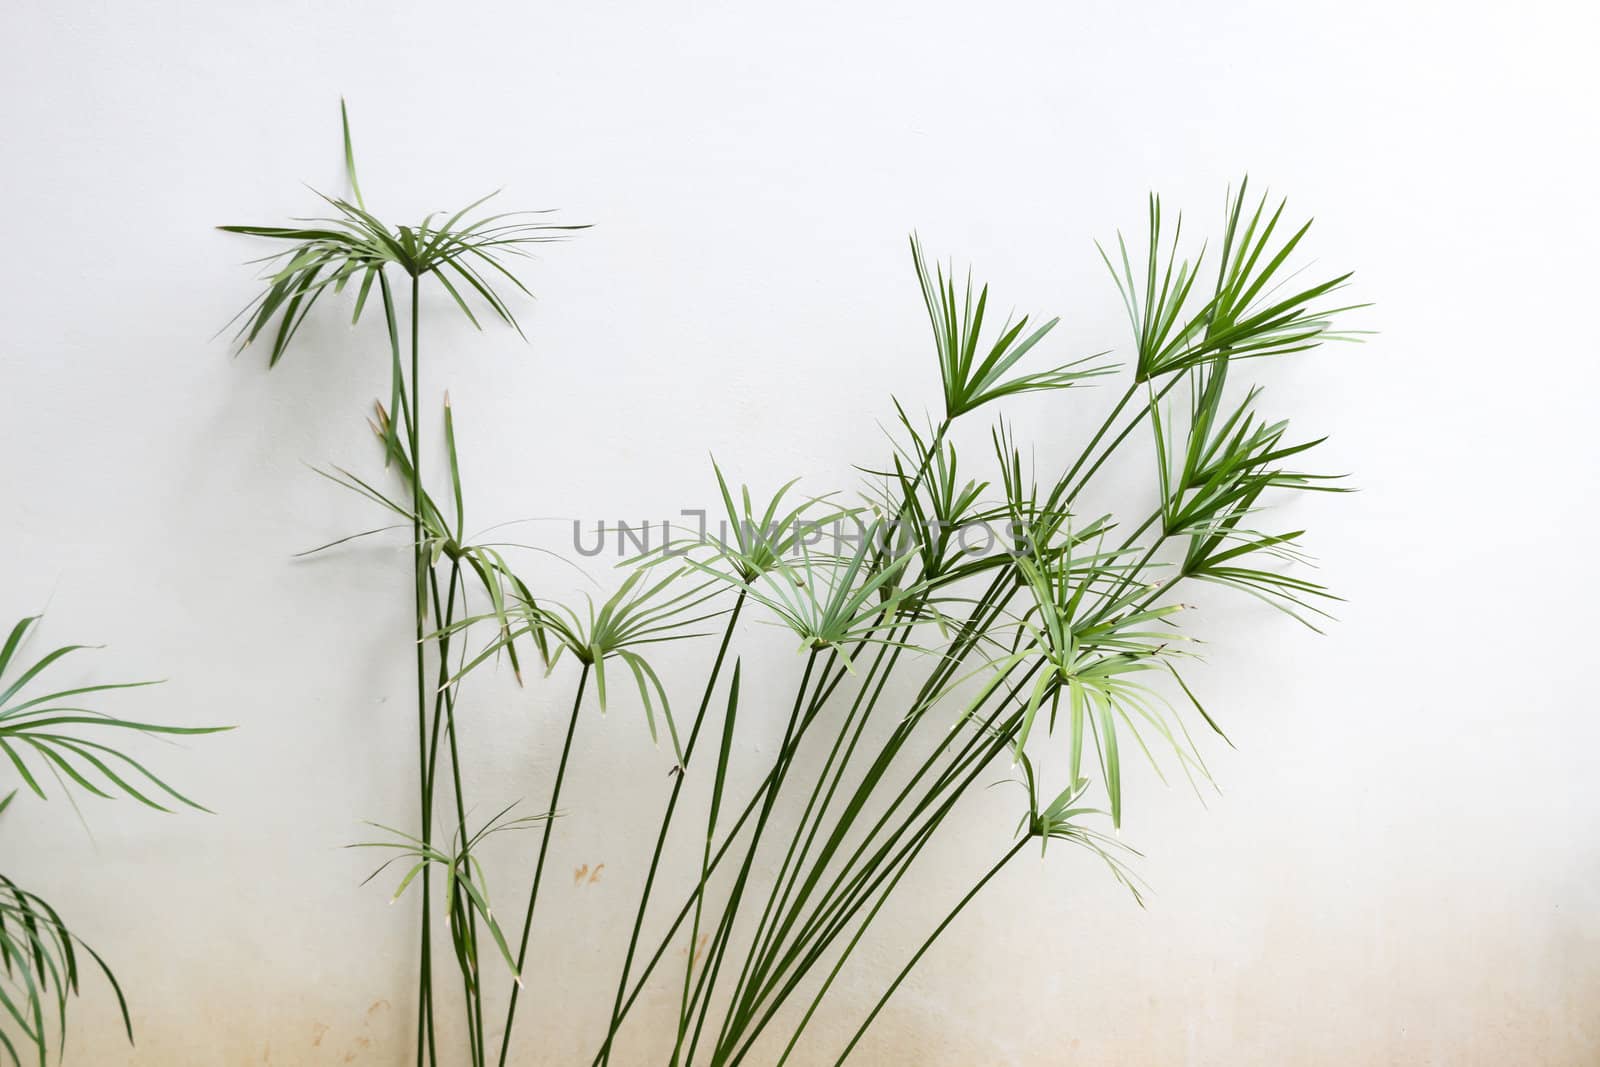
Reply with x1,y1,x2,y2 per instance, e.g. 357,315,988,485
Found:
224,102,1357,1067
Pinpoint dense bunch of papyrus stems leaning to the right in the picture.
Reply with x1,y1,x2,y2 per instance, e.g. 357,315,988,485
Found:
576,186,1352,1067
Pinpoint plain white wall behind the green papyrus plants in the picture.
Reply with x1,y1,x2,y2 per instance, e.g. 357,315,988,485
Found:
0,0,1600,1067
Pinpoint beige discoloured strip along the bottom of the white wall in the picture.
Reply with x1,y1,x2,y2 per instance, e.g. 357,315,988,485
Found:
46,907,1600,1067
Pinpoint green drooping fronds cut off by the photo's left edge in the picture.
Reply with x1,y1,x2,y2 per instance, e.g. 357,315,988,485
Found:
0,616,230,1067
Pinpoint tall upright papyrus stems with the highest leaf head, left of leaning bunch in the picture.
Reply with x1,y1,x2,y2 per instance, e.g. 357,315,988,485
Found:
221,106,604,1064
